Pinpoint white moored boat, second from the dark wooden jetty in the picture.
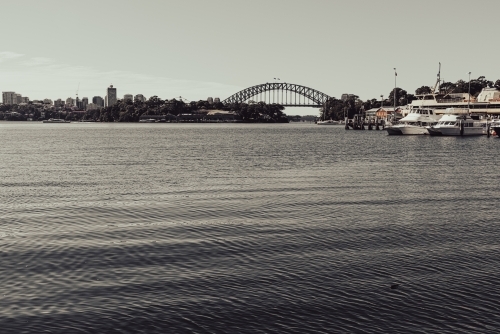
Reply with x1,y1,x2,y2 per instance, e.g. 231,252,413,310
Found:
427,108,486,136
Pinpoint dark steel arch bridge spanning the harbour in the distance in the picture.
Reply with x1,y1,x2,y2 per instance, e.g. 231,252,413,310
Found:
222,82,332,108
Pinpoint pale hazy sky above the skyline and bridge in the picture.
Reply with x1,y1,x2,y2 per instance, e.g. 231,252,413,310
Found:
0,0,500,115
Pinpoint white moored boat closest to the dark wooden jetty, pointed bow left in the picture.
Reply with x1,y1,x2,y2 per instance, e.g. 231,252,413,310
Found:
385,109,441,135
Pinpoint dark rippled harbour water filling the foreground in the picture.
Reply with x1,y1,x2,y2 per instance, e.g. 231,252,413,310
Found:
0,122,500,333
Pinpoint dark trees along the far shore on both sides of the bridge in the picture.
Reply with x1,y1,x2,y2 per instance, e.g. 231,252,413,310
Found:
0,76,500,122
